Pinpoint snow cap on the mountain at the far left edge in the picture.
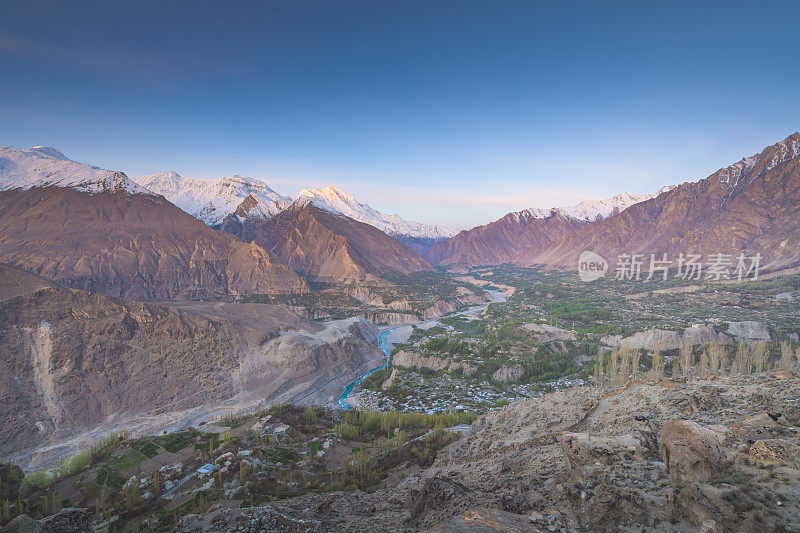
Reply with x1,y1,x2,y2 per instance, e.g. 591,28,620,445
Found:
0,146,151,194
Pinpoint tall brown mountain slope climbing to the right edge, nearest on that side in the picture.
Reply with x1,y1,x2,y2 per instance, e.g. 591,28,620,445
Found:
517,133,800,267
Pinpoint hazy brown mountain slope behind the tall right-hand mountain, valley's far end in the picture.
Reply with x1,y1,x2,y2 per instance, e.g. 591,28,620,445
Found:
423,211,588,265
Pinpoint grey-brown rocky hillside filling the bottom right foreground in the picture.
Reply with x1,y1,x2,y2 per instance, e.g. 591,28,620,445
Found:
175,371,800,532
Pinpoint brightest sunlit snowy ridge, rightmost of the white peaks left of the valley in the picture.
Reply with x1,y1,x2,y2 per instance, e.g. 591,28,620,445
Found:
295,185,456,239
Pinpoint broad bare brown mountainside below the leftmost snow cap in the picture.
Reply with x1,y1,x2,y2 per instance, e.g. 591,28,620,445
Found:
0,187,306,298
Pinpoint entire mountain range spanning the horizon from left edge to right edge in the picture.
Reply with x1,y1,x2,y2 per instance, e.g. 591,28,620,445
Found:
0,133,800,298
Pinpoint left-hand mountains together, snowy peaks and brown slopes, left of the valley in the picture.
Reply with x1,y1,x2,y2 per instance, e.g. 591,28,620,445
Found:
0,147,445,290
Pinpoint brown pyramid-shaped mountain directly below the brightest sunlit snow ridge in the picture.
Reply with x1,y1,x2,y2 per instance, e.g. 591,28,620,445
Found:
223,203,432,281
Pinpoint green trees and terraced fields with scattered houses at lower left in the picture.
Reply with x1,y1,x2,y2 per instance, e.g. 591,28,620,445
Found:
0,404,475,531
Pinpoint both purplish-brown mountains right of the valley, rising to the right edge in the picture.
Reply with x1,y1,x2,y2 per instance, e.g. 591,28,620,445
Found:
425,133,800,268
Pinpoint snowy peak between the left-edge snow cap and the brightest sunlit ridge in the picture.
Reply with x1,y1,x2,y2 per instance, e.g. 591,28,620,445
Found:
136,171,291,226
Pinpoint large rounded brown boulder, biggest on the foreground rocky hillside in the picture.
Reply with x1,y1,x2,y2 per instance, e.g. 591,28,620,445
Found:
661,418,724,483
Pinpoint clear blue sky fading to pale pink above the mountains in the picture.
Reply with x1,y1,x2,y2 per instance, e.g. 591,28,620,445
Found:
0,0,800,229
